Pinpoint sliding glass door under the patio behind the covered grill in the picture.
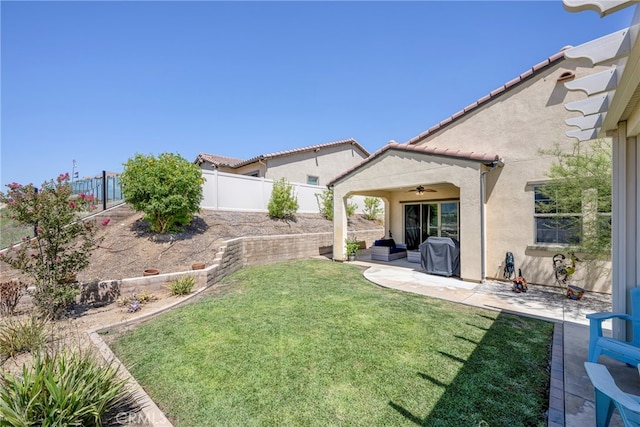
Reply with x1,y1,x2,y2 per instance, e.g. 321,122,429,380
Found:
404,201,460,249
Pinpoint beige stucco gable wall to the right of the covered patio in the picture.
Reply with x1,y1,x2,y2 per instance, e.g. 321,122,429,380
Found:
412,61,610,291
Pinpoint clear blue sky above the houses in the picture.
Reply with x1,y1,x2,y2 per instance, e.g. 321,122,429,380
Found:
0,1,632,191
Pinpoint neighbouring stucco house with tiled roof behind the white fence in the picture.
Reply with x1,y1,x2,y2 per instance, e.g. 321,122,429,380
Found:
195,139,369,185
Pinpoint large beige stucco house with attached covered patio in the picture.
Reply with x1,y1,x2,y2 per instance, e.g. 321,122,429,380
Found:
329,48,610,291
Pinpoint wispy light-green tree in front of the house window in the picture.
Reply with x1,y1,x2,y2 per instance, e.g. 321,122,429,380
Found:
538,139,612,256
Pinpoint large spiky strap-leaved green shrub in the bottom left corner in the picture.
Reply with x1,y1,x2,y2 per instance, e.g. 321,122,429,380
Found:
0,352,136,426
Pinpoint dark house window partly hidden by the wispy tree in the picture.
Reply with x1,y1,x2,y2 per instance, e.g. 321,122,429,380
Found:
534,187,582,245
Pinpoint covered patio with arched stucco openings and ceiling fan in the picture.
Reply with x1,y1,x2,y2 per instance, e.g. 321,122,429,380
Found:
329,142,502,282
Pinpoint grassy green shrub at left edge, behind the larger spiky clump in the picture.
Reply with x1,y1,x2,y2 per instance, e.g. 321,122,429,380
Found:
0,316,49,360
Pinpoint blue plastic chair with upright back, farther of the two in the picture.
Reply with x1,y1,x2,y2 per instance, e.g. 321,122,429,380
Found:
587,288,640,366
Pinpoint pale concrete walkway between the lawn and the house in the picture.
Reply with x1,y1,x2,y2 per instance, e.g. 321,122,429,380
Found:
354,251,640,427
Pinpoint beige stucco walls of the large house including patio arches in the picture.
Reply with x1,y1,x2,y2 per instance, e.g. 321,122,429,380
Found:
334,56,610,292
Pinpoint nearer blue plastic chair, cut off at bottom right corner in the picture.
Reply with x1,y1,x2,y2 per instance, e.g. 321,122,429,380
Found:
584,362,640,427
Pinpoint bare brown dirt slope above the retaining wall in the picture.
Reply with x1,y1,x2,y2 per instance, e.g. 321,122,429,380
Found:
0,205,384,282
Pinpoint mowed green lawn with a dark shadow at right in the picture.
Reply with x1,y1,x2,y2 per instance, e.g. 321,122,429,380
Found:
113,260,553,427
